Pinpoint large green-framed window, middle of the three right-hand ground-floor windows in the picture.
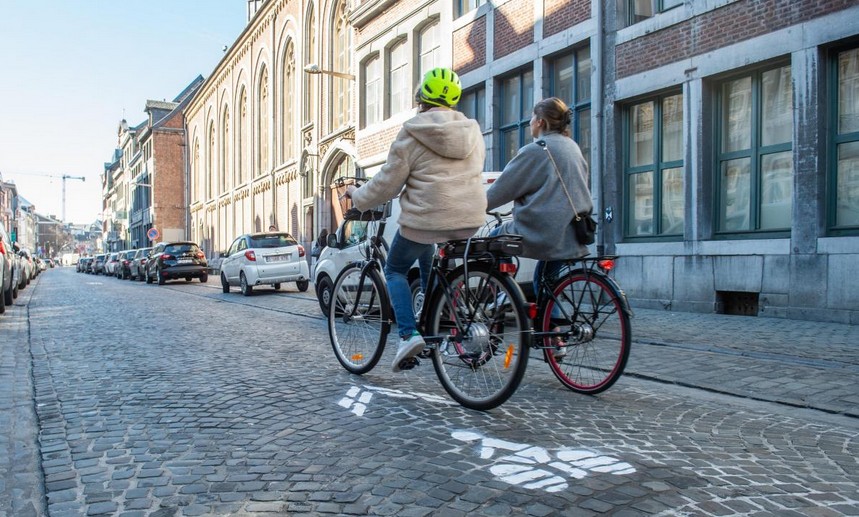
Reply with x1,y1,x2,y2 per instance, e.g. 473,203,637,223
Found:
714,63,794,237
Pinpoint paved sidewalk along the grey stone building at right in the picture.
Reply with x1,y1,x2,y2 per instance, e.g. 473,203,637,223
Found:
626,309,859,418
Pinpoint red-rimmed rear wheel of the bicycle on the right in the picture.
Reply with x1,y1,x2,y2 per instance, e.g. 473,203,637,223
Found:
537,271,632,394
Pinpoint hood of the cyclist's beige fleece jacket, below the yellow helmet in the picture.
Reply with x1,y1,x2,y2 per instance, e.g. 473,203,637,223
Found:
403,110,483,160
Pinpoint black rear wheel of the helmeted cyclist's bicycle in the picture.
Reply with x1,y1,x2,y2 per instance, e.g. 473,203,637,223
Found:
424,264,531,411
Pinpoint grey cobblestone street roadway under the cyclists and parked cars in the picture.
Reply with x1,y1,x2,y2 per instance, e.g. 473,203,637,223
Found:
0,268,859,517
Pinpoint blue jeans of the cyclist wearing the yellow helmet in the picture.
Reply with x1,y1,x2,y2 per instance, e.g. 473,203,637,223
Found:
385,230,435,338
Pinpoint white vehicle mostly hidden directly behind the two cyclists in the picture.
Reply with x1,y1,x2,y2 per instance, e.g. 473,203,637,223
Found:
313,172,536,316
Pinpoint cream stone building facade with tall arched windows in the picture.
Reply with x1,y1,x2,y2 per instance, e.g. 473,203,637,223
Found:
185,0,356,257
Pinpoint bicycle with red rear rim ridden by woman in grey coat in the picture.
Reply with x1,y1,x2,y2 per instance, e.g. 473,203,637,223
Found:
483,212,633,395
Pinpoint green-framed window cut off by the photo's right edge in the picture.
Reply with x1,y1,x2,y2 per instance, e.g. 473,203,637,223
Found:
827,46,859,236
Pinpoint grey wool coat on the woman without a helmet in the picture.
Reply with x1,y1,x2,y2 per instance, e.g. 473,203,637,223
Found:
486,133,593,260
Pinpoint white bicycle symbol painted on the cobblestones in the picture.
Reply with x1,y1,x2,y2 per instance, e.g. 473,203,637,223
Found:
338,386,635,492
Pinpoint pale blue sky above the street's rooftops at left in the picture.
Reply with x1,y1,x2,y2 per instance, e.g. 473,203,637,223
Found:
0,0,247,224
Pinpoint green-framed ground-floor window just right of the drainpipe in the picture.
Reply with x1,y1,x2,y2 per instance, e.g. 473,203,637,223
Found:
624,90,686,240
